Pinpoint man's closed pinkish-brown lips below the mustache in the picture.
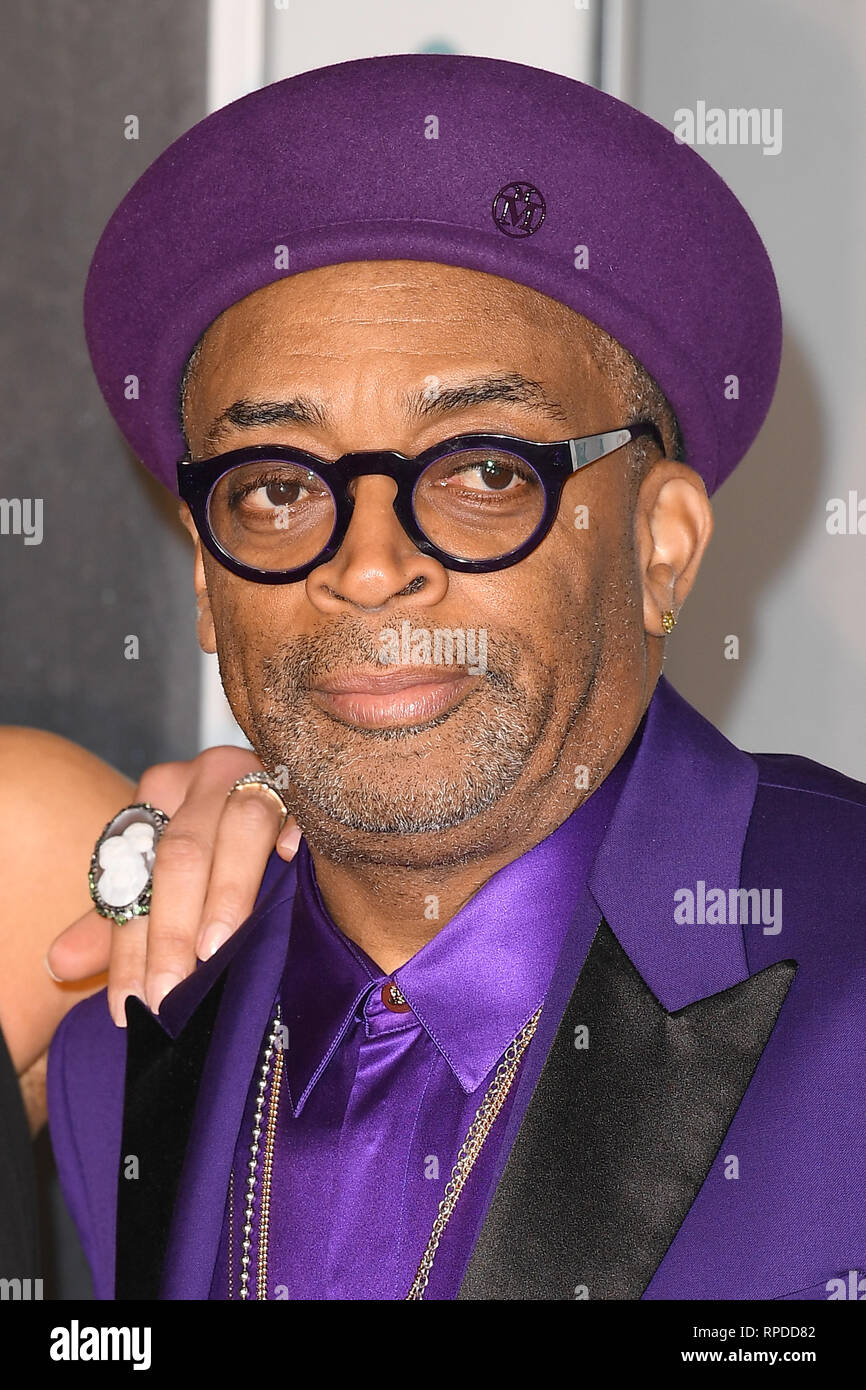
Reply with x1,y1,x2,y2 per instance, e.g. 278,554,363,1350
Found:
310,666,478,728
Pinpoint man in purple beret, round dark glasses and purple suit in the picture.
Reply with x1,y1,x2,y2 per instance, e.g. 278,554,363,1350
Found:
49,56,866,1300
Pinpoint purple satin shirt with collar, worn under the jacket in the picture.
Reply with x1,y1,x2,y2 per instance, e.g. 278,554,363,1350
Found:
210,724,644,1300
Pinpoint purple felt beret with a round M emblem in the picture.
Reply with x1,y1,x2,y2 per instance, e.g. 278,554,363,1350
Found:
85,53,781,492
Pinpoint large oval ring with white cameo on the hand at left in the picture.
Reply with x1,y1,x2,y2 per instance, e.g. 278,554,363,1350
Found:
88,802,168,926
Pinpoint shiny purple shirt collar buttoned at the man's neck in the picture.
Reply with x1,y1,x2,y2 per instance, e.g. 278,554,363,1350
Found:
281,724,644,1113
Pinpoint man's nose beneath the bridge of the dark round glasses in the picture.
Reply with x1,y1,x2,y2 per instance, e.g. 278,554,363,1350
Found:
307,474,448,613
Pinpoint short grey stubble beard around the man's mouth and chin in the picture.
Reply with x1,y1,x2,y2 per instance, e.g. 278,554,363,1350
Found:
233,619,549,859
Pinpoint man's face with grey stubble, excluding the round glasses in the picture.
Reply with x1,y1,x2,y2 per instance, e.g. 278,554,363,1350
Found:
186,261,664,865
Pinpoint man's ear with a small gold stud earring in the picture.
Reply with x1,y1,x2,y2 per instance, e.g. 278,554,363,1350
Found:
634,459,713,637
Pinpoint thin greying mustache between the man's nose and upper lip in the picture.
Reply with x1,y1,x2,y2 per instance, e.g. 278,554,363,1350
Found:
258,612,523,701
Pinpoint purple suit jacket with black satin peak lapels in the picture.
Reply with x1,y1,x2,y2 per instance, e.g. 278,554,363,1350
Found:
49,678,866,1300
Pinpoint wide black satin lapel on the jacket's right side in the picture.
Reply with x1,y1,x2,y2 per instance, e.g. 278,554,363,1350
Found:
457,922,796,1300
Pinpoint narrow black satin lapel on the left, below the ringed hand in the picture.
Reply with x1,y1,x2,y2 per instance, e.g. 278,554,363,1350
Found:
114,973,225,1300
